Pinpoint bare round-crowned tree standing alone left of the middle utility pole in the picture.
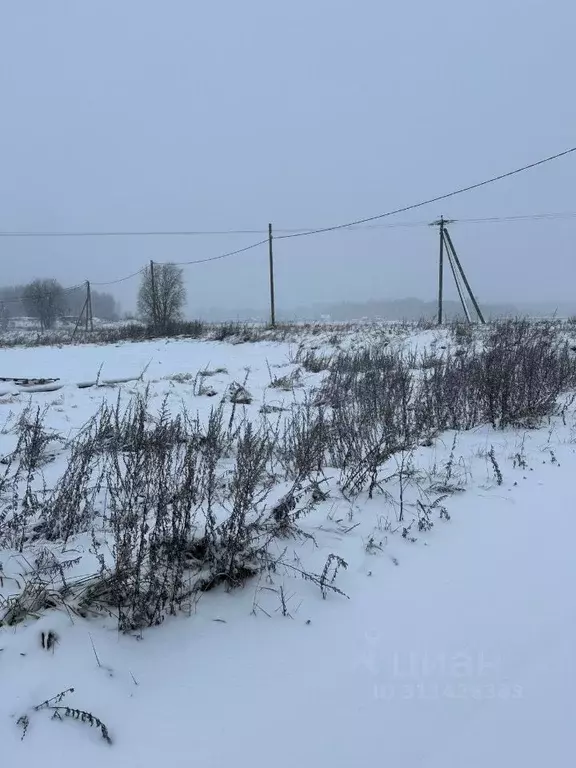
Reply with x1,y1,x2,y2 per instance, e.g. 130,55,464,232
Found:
138,264,186,332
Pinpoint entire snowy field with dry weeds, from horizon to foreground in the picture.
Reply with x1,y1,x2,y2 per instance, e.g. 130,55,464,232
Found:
0,321,576,768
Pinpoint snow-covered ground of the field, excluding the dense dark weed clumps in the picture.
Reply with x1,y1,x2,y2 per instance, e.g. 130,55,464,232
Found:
0,320,576,768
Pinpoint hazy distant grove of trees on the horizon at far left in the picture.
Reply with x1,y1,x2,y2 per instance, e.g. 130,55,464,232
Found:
0,278,120,330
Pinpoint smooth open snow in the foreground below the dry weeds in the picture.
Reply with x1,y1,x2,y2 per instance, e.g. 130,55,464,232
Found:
0,436,576,768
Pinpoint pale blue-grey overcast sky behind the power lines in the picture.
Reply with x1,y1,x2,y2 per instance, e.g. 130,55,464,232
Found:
0,0,576,314
